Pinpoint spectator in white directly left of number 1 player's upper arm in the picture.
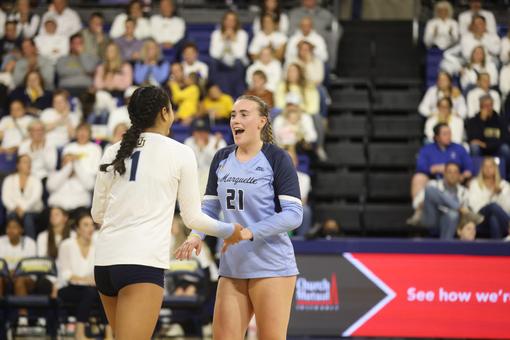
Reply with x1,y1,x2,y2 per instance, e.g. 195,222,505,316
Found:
46,149,94,211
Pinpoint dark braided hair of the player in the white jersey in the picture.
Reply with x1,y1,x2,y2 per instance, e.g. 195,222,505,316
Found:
99,86,170,175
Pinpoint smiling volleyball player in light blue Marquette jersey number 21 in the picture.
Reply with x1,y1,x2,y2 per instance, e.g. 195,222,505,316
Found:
176,96,303,340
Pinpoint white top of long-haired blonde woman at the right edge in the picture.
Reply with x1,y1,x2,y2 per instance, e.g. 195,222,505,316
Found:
468,178,510,213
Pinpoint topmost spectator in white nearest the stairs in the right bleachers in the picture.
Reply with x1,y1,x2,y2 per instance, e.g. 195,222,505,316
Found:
423,1,459,50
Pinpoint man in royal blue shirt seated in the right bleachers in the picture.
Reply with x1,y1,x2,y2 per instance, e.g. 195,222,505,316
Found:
411,123,473,205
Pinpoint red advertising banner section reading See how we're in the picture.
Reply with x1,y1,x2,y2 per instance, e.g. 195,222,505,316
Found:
346,254,510,339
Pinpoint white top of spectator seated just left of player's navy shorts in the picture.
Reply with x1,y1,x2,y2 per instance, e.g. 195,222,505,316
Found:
57,237,96,288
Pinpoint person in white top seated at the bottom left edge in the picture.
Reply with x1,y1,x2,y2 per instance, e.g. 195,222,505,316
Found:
0,216,37,296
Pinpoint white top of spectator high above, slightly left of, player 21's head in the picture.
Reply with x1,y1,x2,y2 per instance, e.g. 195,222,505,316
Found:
209,29,248,64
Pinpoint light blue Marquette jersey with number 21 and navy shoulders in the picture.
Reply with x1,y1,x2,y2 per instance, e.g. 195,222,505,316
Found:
198,144,303,279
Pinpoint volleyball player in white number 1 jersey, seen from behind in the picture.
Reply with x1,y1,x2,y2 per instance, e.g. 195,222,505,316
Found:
92,87,242,340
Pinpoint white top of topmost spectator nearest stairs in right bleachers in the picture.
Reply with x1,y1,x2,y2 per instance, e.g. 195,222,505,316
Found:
423,18,459,50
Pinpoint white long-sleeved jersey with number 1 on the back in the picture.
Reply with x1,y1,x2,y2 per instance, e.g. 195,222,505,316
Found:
92,132,234,269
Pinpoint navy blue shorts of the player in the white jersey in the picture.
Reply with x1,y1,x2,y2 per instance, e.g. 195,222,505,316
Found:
94,264,165,296
